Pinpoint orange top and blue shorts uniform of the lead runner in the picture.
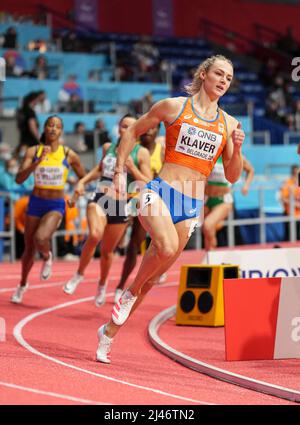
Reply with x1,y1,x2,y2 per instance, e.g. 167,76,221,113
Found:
142,97,228,224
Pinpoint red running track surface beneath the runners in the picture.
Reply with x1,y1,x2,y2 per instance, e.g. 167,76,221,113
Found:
0,251,293,405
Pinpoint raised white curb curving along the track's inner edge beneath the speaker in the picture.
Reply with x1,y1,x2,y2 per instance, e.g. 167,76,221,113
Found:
148,305,300,403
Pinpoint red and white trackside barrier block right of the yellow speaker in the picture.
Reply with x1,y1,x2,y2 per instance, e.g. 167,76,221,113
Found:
224,277,300,361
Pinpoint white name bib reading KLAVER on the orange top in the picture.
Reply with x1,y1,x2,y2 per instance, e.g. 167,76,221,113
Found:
175,123,222,161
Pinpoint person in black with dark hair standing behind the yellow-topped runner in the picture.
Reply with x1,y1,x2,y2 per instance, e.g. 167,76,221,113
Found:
17,92,40,153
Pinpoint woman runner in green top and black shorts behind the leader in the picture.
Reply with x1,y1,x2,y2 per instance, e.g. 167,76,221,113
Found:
63,115,151,307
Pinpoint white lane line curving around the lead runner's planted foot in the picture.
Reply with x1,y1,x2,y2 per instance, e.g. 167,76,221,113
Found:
13,292,212,405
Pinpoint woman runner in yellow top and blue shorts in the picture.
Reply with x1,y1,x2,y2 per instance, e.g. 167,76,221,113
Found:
11,115,85,304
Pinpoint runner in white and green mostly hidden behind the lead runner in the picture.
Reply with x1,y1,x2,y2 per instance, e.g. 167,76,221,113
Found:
202,157,254,251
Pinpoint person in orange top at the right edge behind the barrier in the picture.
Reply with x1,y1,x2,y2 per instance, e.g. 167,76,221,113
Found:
280,165,300,240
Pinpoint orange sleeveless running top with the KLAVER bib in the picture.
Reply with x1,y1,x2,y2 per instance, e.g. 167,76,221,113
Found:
165,97,228,177
